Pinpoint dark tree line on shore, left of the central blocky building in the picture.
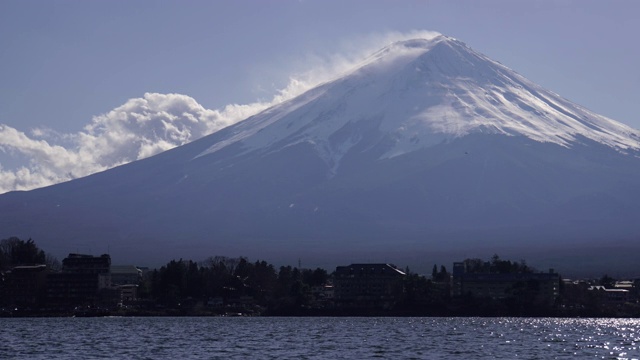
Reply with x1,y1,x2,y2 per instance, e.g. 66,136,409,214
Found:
140,256,329,311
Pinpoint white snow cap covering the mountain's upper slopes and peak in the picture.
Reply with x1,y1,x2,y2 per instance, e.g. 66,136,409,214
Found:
199,36,640,172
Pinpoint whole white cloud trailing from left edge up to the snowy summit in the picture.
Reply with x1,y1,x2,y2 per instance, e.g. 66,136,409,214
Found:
0,31,438,193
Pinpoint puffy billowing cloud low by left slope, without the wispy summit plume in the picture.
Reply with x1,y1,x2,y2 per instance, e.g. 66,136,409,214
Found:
0,93,258,192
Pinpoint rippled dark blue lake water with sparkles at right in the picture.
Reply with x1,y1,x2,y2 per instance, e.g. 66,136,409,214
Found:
0,317,640,359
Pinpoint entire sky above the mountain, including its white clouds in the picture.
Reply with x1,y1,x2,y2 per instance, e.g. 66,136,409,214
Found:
0,0,640,192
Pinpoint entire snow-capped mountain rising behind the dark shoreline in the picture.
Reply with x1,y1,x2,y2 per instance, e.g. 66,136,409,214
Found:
0,36,640,275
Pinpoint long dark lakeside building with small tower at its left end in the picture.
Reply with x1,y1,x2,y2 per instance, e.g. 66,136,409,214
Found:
452,262,560,305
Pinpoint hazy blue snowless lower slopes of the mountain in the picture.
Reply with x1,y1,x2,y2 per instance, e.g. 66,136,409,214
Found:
0,135,640,273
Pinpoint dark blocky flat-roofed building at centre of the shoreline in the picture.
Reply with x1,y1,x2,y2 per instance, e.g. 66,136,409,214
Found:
333,264,405,309
